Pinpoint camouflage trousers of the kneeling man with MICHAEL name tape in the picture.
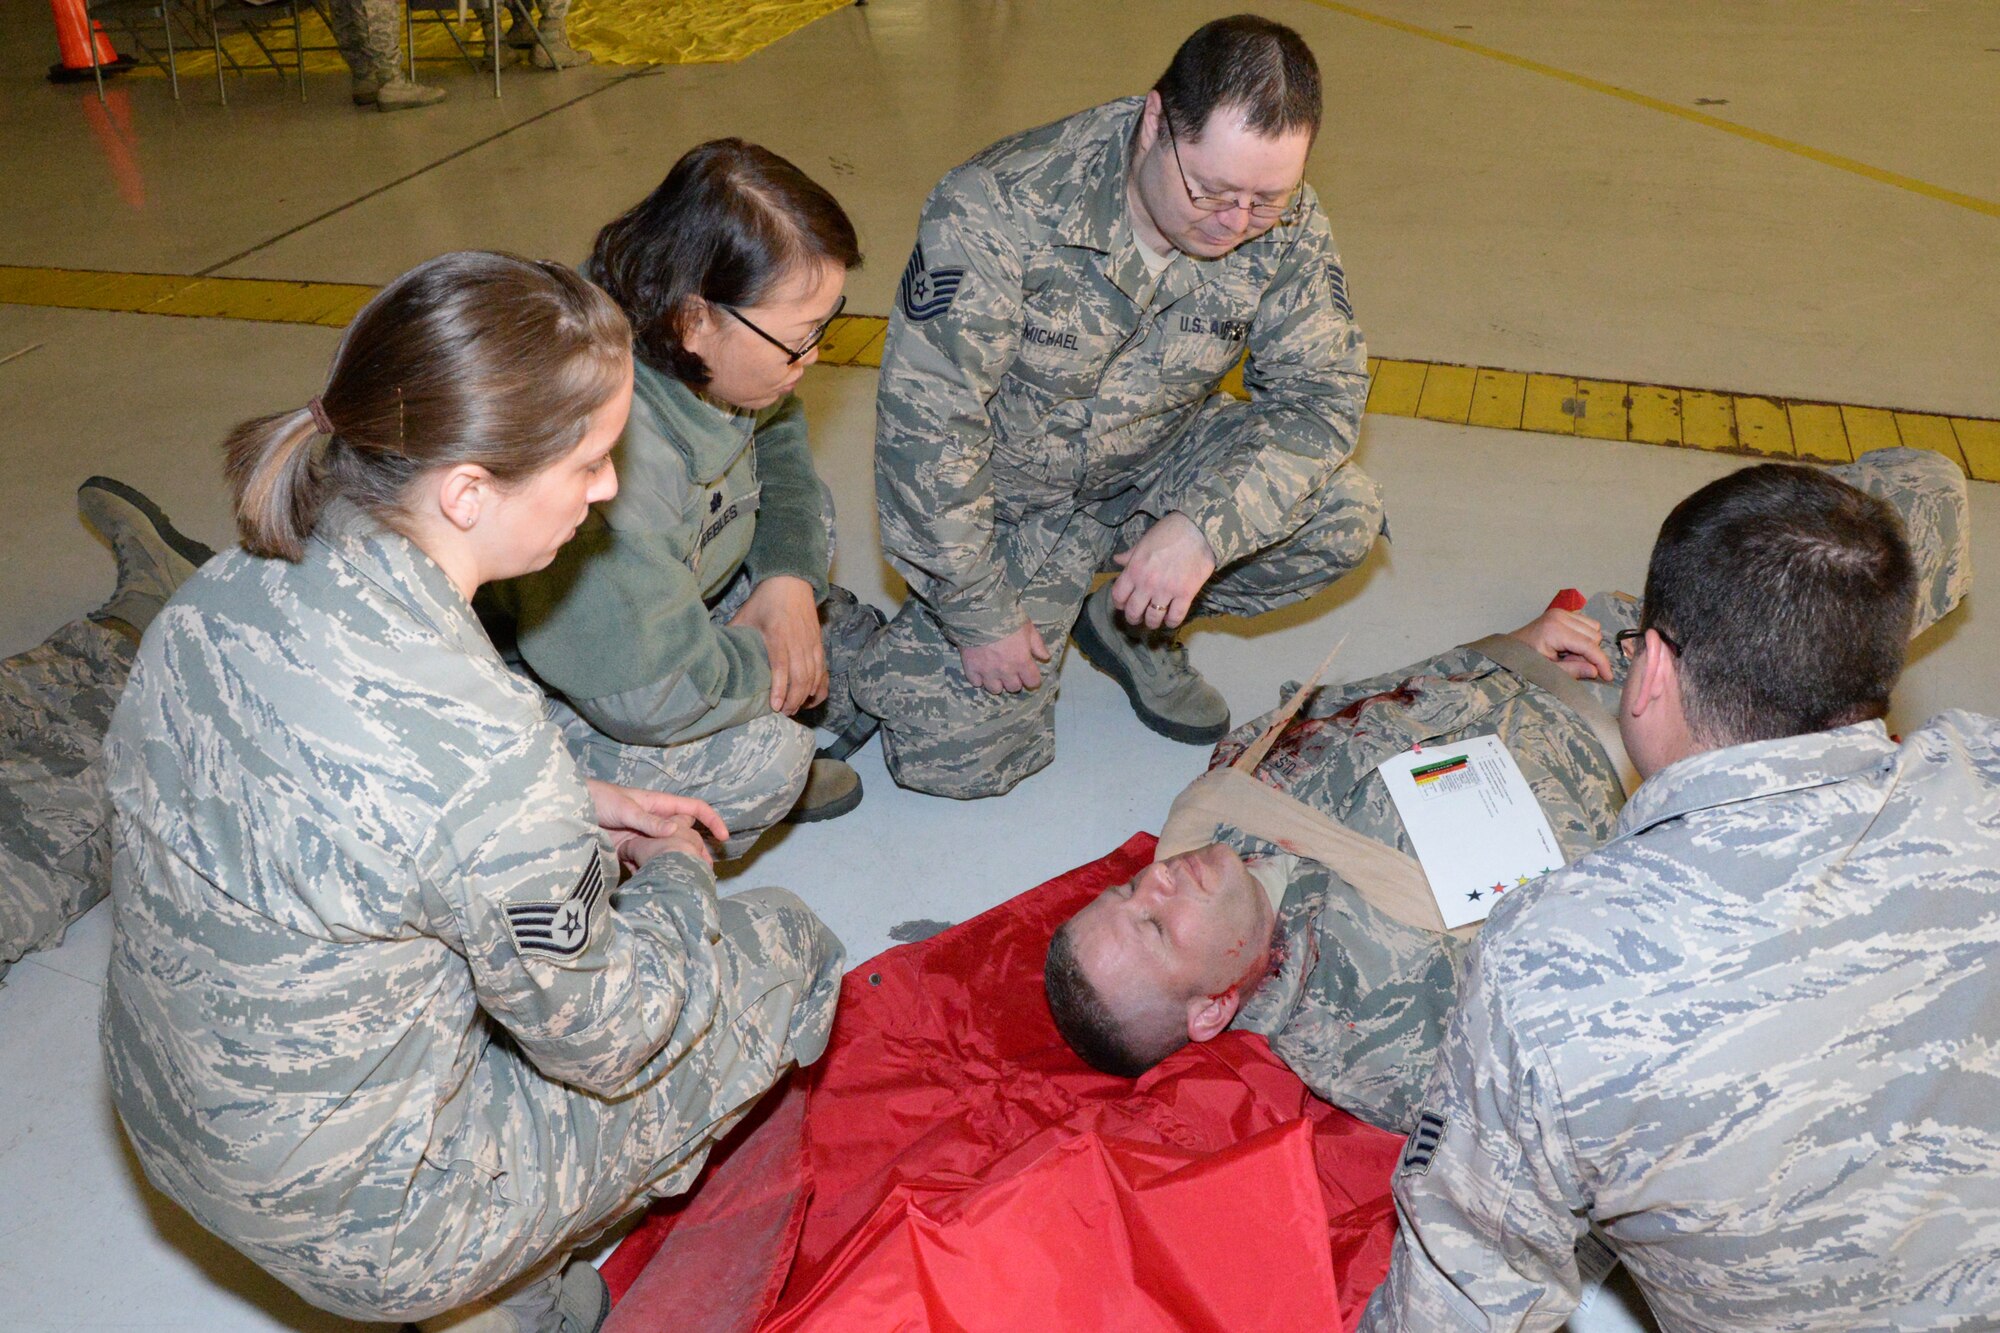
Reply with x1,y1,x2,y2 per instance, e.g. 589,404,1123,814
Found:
854,458,1382,799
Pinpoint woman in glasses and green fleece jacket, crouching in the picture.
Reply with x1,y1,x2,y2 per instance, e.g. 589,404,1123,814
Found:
480,138,882,853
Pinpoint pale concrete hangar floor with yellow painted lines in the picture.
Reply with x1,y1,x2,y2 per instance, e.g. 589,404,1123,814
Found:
0,0,2000,1331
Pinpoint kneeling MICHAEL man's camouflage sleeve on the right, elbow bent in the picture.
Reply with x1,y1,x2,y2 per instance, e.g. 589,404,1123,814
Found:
1168,190,1368,564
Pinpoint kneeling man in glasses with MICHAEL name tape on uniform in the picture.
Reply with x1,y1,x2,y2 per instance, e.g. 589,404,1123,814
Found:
854,14,1382,799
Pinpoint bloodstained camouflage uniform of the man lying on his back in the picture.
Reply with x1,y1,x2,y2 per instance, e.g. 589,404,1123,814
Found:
1216,448,1970,1128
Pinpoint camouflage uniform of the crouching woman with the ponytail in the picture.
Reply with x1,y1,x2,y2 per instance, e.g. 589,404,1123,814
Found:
104,504,842,1319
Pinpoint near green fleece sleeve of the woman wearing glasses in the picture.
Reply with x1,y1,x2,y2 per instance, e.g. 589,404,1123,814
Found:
510,516,770,745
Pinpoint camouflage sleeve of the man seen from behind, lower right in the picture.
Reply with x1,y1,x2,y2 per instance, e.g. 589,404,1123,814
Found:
1362,923,1590,1329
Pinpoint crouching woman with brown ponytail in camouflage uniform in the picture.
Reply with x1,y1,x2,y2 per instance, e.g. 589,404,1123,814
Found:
104,252,842,1333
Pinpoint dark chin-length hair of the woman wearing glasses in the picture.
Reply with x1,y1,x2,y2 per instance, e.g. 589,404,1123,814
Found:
590,138,862,388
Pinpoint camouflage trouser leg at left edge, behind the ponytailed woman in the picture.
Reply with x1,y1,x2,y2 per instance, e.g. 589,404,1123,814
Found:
0,620,136,977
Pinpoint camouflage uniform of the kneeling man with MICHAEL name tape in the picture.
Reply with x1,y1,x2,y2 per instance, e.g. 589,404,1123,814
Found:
854,98,1382,797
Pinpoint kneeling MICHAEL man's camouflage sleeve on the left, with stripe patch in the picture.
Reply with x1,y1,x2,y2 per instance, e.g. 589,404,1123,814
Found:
876,166,1026,644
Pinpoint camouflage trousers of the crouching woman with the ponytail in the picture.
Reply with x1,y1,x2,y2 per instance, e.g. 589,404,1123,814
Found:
288,889,844,1319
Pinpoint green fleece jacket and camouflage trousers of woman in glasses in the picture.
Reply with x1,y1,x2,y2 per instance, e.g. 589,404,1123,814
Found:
478,364,882,855
